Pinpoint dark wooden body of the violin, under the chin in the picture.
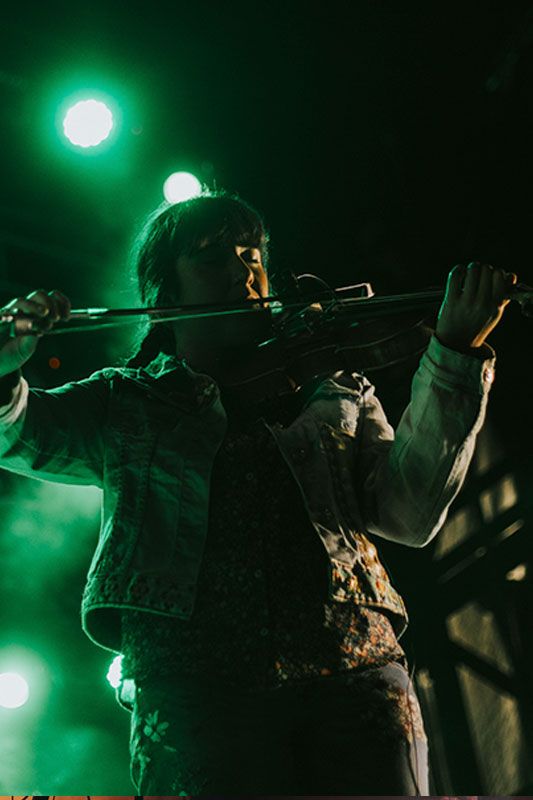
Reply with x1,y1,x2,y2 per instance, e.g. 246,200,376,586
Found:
221,304,433,421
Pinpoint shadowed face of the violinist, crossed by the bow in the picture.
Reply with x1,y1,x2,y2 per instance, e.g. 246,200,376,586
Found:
171,234,269,354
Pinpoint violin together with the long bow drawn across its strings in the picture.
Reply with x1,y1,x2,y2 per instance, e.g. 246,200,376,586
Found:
0,274,533,422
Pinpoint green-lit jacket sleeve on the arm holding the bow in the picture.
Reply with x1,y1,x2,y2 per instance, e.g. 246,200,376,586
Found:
0,370,110,486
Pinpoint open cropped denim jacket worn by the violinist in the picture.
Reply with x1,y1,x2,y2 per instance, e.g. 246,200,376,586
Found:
0,337,494,651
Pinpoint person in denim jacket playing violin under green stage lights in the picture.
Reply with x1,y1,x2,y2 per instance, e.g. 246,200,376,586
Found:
0,192,516,796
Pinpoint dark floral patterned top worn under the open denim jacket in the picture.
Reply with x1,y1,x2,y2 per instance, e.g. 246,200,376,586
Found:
122,392,404,688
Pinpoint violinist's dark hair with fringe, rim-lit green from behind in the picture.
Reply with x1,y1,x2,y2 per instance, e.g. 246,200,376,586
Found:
127,191,269,367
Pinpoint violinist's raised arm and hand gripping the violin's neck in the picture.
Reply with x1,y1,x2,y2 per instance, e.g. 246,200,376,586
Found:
356,264,516,547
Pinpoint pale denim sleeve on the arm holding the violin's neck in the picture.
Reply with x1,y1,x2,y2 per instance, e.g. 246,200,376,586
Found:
356,337,495,547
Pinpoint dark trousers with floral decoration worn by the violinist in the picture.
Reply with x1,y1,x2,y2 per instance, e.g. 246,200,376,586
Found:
130,663,428,796
